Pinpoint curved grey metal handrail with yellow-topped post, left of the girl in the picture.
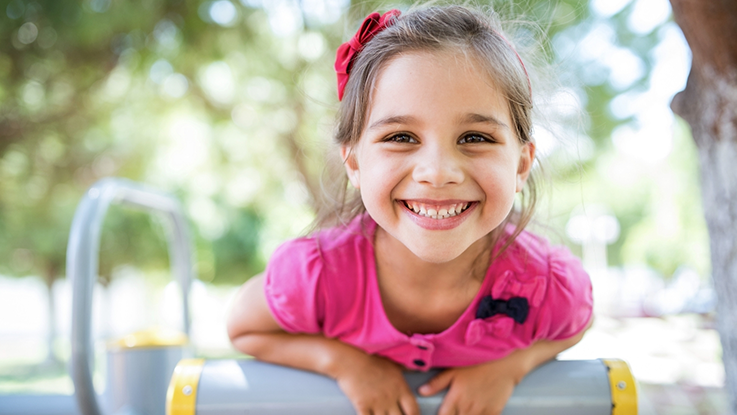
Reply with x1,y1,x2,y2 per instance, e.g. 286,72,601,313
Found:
67,179,192,415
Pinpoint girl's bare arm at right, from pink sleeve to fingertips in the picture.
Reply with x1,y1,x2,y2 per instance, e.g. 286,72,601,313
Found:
419,323,591,415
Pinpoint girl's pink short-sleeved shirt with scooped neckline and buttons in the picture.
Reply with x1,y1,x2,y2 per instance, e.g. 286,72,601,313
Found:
264,215,593,370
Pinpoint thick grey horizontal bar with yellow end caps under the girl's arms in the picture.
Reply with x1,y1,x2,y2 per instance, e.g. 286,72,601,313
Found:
167,359,637,415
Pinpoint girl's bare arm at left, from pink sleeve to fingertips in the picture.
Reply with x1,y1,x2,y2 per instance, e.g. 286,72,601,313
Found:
227,275,420,415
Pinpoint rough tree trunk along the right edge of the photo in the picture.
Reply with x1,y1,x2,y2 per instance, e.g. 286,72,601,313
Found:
671,0,737,414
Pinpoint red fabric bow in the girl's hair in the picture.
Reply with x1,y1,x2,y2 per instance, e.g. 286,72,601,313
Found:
335,9,401,100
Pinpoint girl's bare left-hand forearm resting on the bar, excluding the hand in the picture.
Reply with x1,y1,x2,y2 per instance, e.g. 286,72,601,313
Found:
232,332,368,379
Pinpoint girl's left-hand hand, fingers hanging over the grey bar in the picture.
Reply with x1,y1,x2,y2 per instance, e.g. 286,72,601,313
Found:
335,354,420,415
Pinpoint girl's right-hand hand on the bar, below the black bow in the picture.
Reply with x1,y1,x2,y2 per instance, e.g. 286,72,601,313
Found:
419,355,525,415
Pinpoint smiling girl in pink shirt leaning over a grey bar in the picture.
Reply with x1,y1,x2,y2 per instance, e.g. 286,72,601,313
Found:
228,6,592,415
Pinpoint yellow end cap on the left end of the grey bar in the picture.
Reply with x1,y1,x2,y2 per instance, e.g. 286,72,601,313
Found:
166,359,205,415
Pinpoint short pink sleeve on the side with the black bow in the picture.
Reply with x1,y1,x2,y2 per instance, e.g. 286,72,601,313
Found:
534,247,593,340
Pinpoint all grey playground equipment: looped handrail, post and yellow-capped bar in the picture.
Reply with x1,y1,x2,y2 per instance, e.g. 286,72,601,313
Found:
0,179,637,415
